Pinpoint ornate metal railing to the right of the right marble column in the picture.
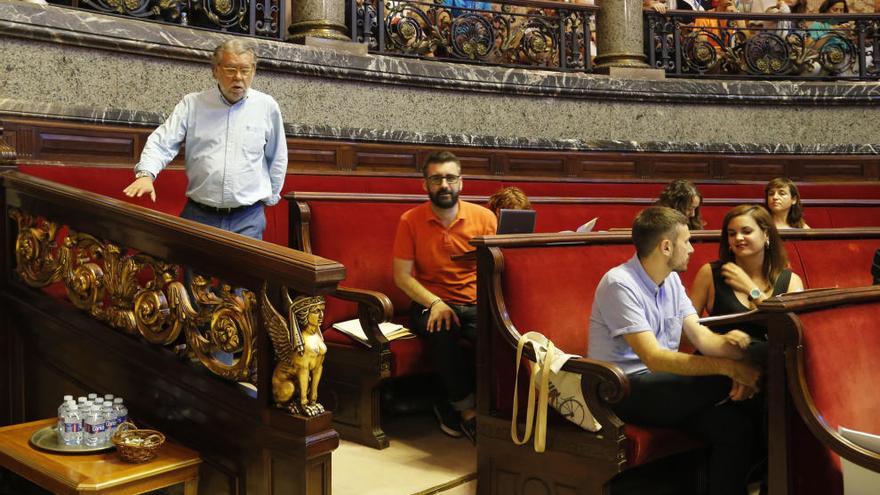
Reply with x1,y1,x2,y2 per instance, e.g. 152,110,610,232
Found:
645,11,880,80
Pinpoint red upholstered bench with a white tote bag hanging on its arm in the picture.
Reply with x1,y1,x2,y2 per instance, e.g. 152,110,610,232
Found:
473,232,744,495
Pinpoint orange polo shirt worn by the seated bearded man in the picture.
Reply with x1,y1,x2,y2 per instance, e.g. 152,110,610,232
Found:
394,201,498,304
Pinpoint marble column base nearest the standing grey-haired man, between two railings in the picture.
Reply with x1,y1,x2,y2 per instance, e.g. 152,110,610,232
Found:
287,0,351,43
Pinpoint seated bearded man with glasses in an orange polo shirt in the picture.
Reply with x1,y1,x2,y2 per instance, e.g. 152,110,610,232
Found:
393,151,497,442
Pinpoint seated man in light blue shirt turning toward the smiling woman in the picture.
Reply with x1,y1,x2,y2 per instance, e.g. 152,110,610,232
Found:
589,206,760,495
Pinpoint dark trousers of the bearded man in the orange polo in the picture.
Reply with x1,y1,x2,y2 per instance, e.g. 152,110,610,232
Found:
409,303,477,411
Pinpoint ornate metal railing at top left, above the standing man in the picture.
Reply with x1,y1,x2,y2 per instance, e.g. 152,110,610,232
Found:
48,0,286,39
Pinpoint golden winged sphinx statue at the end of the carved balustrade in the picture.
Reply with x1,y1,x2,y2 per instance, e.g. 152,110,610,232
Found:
262,289,327,417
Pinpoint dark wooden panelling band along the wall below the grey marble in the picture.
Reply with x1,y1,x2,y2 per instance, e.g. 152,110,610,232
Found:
0,118,880,181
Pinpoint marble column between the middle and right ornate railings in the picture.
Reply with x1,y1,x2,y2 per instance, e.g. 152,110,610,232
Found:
596,0,648,72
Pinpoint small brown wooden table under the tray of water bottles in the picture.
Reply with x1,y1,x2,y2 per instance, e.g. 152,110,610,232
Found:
0,419,202,495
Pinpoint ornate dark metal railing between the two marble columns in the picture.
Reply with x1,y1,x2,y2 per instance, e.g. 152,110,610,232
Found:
348,0,598,72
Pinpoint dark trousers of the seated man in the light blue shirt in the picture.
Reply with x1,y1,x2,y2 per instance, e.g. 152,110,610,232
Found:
612,371,766,495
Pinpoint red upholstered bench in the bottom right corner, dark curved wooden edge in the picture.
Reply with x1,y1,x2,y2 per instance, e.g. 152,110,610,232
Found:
762,286,880,495
